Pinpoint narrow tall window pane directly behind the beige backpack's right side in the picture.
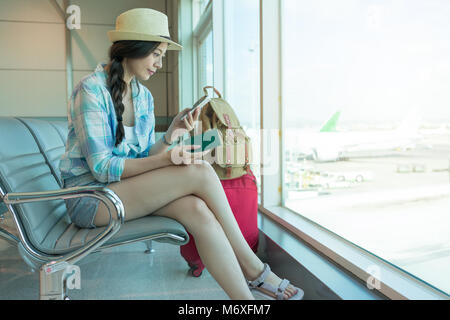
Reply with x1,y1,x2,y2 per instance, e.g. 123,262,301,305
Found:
223,0,261,193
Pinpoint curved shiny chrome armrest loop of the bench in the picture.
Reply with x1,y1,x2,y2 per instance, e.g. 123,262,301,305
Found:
2,186,125,264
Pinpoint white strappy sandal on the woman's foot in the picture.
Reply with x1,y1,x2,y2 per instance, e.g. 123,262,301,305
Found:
247,263,305,300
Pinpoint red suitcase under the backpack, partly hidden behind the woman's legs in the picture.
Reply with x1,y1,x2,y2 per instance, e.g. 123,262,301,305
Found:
180,169,259,277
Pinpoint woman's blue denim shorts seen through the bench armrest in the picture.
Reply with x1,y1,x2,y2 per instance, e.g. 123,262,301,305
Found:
64,177,108,228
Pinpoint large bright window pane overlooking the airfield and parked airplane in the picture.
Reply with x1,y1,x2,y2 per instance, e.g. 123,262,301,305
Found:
281,0,450,293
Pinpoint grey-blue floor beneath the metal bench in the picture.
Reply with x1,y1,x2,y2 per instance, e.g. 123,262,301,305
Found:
0,225,229,300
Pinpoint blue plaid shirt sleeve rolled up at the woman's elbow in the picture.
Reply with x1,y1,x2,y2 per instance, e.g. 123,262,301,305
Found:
72,84,125,183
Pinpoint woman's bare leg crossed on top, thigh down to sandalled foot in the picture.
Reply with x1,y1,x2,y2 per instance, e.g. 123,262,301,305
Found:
95,162,295,297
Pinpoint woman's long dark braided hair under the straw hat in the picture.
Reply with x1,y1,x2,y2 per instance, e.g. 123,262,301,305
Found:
107,40,170,146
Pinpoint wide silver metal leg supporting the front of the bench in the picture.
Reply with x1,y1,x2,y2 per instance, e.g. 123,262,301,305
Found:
39,262,81,300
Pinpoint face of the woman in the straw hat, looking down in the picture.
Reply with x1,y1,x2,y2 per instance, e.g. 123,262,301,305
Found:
128,42,168,81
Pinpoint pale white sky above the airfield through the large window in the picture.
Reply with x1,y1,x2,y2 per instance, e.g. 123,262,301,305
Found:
283,0,450,127
